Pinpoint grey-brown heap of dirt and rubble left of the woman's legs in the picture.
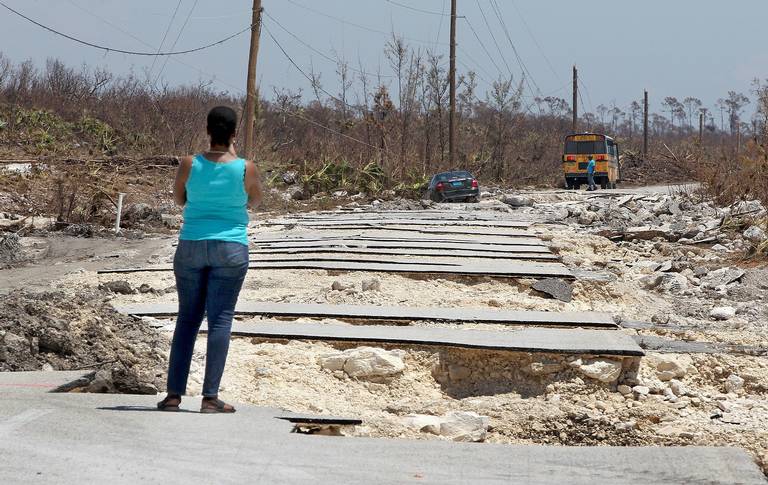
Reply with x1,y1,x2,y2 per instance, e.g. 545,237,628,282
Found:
0,290,168,394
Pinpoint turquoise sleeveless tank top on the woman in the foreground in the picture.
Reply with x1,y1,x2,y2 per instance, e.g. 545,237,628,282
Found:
179,155,248,246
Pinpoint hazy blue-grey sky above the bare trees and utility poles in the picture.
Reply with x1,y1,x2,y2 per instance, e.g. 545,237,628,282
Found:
0,0,768,112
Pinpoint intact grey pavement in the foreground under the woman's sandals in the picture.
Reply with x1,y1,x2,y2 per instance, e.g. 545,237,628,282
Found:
0,374,765,485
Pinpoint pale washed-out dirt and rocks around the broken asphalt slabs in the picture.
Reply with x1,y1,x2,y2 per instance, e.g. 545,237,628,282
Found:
0,186,768,470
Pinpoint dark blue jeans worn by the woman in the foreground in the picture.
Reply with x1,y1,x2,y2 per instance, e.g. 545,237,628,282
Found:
168,241,248,397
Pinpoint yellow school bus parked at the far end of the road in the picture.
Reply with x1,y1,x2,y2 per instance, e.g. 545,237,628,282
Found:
563,133,621,190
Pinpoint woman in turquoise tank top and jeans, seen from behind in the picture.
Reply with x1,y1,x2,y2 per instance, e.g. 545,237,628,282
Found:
157,106,262,413
